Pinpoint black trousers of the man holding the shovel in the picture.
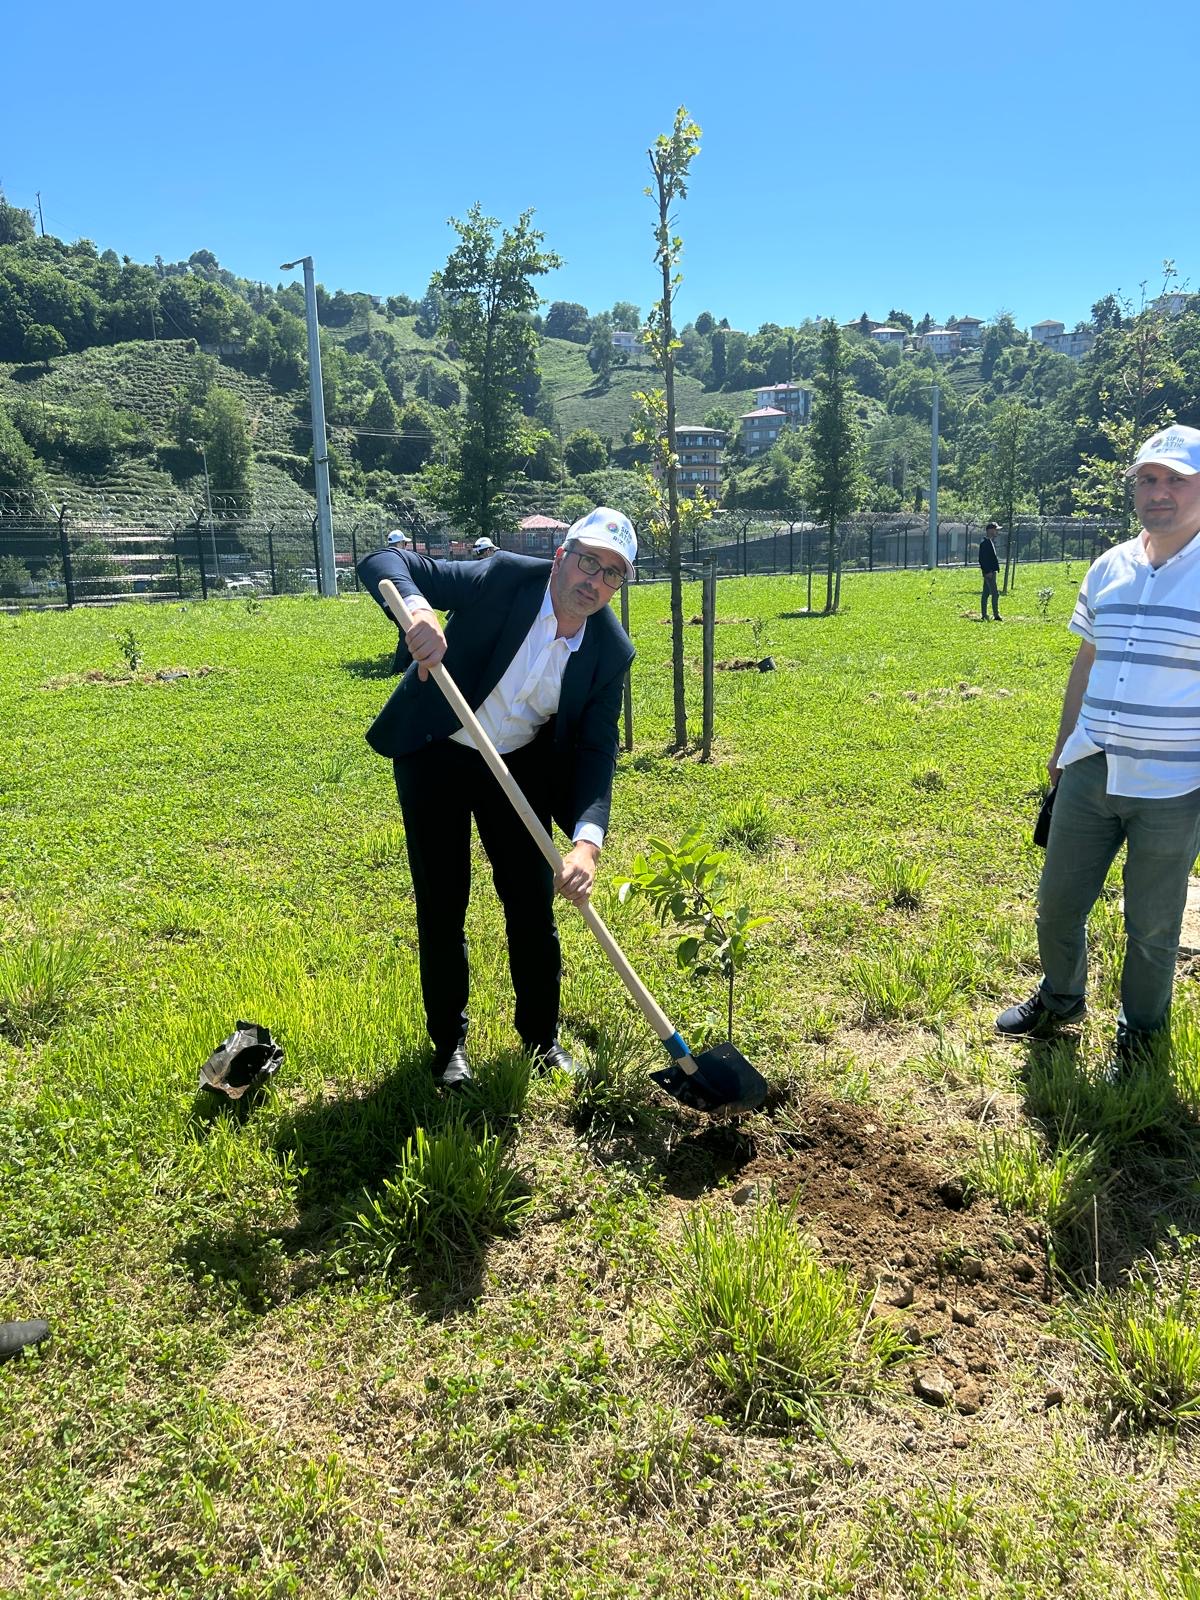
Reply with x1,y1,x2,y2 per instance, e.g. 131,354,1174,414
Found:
394,738,562,1059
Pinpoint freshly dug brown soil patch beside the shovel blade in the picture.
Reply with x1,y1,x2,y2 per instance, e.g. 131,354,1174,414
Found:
669,1099,1051,1414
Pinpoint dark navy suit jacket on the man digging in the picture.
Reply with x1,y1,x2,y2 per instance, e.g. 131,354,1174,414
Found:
358,550,634,838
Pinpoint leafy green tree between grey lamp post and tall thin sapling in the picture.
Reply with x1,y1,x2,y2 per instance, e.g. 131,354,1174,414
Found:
430,205,562,534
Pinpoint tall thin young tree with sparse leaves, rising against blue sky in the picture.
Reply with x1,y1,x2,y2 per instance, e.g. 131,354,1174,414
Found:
646,106,701,750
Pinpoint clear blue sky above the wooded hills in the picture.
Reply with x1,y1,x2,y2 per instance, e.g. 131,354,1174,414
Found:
0,0,1200,330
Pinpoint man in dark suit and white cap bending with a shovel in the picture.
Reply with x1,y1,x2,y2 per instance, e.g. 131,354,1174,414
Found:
358,506,637,1086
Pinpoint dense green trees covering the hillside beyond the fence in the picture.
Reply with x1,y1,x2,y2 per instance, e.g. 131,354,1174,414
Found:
0,183,1200,528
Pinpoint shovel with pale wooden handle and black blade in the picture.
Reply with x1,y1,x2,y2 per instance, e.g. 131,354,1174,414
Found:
379,578,766,1112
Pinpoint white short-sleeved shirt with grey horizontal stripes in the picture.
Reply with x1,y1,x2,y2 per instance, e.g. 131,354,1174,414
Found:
1059,534,1200,800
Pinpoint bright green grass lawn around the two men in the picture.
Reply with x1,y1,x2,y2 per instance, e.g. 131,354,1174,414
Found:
0,563,1200,1600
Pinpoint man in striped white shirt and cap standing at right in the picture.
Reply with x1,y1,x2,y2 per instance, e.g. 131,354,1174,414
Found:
995,424,1200,1070
